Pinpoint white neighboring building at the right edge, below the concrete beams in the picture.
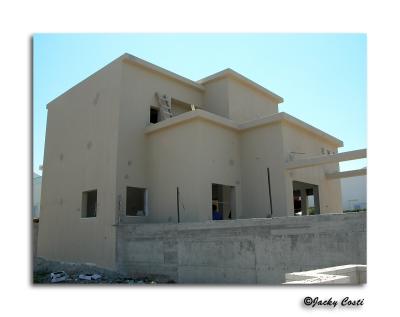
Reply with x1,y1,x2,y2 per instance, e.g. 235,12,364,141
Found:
341,175,367,210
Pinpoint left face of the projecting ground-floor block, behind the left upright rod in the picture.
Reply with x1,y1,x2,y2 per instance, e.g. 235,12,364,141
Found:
148,121,200,222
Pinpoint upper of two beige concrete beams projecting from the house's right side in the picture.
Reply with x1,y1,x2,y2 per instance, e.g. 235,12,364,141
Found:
285,149,367,169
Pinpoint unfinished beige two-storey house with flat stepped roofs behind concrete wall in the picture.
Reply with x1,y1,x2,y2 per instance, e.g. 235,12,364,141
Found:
38,54,366,268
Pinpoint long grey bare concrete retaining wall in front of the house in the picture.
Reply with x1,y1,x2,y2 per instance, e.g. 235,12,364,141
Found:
117,212,366,284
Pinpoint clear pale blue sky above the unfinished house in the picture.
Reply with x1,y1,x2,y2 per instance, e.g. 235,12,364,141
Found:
33,33,367,174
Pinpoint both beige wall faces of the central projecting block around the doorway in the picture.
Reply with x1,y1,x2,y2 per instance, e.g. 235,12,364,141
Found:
148,119,241,222
